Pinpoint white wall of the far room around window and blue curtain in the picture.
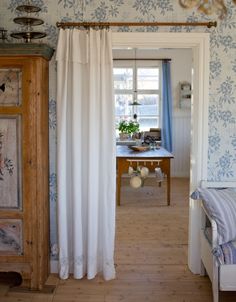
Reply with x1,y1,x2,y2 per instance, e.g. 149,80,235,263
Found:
113,49,192,177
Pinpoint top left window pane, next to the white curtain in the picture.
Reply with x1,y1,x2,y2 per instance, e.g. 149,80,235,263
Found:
113,68,133,89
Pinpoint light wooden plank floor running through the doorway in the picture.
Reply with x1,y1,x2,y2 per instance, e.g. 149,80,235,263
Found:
0,179,236,302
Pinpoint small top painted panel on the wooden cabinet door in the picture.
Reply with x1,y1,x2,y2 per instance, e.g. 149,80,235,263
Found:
0,68,22,106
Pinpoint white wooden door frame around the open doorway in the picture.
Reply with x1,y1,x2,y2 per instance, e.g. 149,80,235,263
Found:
112,32,209,274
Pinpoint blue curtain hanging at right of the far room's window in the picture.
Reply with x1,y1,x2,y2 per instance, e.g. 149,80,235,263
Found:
161,60,172,152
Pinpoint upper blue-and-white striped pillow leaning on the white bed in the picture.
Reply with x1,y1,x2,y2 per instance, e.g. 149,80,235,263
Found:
191,188,236,244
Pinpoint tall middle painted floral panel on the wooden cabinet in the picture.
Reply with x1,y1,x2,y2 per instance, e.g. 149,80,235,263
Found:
0,115,21,209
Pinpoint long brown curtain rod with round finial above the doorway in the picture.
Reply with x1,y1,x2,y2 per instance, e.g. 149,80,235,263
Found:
56,21,217,28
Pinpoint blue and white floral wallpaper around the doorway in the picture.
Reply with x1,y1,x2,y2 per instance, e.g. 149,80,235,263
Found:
0,0,236,259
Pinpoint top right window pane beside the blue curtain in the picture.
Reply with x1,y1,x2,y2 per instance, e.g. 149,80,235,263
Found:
137,68,159,89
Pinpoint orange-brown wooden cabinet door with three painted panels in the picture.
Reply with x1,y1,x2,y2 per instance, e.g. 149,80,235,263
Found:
0,58,31,262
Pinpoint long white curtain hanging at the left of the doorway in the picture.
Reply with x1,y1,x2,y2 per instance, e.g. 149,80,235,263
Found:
56,29,116,280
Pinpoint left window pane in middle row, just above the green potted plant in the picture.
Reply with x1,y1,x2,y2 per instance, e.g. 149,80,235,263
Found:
115,94,132,118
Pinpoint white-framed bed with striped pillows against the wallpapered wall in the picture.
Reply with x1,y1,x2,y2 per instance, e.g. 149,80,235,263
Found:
191,188,236,302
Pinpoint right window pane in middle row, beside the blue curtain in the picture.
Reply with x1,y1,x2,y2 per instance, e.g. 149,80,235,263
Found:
137,94,160,115
